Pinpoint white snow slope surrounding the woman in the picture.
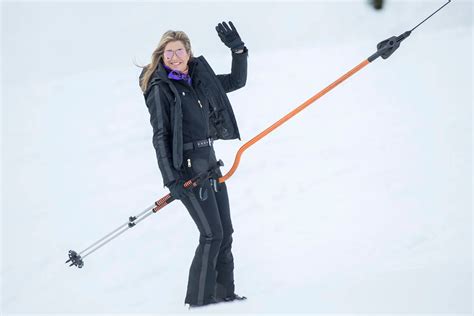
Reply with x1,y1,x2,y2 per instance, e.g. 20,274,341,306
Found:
1,0,473,315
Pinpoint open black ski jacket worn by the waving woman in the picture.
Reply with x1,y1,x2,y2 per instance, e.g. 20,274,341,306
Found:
140,48,248,186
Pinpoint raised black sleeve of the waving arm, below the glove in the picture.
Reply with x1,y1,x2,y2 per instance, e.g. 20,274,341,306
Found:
217,47,248,93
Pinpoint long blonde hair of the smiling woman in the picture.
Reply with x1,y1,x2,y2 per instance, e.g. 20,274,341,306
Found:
136,30,193,93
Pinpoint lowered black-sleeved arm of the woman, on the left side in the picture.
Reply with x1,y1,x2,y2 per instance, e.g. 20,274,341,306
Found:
146,84,180,186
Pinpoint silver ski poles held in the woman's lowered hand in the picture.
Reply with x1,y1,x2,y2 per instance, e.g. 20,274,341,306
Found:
66,160,224,268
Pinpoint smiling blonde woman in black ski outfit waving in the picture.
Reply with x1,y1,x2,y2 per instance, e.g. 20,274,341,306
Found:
140,22,248,307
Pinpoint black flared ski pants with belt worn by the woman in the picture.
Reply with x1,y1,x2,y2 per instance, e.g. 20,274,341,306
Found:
181,147,234,305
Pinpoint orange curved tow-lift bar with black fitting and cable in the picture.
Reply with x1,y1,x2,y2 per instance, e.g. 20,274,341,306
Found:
218,0,451,183
